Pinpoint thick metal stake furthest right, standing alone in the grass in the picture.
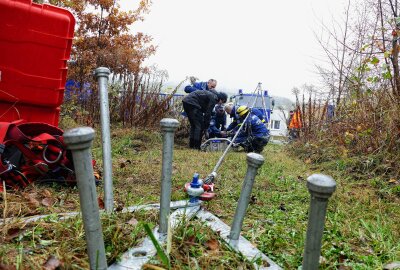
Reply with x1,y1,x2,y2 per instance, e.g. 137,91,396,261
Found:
303,174,336,270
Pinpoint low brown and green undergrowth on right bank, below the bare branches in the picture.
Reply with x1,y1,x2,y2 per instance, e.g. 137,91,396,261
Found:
289,91,400,182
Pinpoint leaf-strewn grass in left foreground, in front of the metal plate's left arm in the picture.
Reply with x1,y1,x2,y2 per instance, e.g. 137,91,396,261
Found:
0,211,157,269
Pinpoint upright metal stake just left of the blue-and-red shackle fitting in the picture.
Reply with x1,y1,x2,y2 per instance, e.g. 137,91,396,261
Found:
159,118,179,236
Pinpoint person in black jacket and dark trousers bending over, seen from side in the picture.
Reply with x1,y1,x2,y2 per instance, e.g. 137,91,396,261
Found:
182,89,228,150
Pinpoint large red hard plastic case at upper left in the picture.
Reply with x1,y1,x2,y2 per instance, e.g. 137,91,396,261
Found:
0,0,75,125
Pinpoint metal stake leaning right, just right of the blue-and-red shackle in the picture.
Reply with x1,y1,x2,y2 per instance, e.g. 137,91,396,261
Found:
229,153,264,244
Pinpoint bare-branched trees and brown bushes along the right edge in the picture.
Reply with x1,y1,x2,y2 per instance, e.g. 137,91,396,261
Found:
292,0,400,184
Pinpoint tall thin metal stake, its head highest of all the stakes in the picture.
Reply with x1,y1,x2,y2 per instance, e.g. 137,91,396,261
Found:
95,67,114,213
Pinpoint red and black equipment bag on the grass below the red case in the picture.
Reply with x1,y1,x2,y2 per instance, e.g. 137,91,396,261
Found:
0,121,76,191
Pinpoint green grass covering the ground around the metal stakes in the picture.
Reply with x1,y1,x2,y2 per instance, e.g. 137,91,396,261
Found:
0,129,400,269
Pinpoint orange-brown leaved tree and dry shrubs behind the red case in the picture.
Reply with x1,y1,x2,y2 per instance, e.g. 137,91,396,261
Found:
38,0,185,127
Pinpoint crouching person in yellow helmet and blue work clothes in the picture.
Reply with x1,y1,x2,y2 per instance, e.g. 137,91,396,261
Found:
234,107,270,153
